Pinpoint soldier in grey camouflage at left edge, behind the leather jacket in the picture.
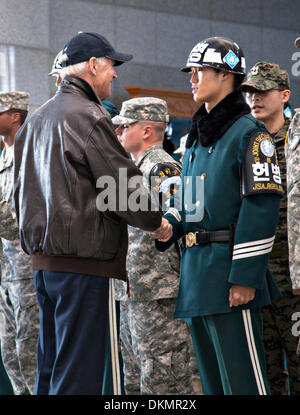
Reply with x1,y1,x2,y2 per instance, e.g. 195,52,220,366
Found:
0,92,39,395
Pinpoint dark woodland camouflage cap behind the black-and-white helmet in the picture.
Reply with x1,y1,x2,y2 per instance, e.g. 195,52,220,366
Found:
241,62,290,92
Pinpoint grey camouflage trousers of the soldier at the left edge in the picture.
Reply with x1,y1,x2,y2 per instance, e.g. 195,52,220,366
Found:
0,278,39,395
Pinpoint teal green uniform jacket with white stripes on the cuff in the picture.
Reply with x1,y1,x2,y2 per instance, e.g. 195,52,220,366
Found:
157,101,280,318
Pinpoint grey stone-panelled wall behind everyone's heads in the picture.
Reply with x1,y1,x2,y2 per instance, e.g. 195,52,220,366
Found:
0,0,300,112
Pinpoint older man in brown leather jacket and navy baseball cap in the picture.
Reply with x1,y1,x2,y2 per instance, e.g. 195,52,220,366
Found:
14,33,170,395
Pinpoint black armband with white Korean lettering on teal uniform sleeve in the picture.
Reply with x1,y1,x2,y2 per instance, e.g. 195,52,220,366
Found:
241,130,283,196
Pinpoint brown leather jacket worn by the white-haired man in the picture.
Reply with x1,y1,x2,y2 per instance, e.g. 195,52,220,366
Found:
14,76,162,279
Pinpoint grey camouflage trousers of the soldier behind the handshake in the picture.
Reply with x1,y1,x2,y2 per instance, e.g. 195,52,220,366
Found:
120,298,194,395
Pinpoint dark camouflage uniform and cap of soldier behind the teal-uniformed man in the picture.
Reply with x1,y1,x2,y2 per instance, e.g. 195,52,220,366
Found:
242,62,300,395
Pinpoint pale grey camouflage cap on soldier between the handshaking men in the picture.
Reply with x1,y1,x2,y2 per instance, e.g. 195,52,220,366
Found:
112,97,169,125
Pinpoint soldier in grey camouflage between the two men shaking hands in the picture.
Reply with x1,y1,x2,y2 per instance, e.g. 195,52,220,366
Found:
112,97,193,395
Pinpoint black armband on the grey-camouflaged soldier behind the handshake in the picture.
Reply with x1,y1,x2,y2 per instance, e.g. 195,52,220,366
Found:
149,162,181,211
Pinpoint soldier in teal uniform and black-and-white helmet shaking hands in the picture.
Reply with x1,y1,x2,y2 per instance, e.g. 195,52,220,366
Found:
152,37,282,395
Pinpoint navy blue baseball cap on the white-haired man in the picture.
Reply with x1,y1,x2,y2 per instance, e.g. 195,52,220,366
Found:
61,32,133,67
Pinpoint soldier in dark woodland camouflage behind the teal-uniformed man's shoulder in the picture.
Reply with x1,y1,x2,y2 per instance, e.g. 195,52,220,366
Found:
242,62,300,395
